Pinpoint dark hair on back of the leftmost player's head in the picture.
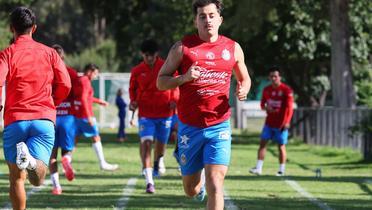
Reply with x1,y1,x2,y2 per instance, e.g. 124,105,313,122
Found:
10,7,36,34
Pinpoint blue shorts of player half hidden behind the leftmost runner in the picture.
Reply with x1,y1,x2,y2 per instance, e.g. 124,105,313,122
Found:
54,115,76,151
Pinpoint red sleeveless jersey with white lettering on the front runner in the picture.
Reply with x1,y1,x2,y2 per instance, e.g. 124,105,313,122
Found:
177,35,236,127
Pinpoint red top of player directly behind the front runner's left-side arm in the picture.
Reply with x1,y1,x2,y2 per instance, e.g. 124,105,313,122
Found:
129,57,178,118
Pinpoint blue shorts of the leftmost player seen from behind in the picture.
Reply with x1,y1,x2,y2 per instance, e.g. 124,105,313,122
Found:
3,120,55,165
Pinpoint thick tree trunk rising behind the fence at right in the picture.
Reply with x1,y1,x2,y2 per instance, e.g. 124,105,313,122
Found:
330,0,356,108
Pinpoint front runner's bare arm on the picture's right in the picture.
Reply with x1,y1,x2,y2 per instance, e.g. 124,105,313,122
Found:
234,43,251,100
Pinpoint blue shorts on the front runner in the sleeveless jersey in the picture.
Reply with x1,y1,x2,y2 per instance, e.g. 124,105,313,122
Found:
176,121,231,176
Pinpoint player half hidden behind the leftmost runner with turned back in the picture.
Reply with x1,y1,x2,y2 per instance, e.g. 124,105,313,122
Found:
49,44,78,195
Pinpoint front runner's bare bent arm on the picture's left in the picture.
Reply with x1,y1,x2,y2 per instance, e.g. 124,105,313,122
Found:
156,41,185,90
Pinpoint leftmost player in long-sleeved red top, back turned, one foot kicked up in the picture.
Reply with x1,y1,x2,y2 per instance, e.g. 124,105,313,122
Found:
0,7,71,209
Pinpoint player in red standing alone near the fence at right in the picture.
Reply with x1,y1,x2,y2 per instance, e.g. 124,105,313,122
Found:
249,67,293,176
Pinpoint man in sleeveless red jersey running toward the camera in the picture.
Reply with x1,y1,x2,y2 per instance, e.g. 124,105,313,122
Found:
157,0,251,209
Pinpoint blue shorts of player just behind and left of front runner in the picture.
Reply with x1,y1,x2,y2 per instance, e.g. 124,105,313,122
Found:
138,117,172,144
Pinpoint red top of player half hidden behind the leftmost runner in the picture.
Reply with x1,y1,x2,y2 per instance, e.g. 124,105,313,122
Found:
57,66,78,116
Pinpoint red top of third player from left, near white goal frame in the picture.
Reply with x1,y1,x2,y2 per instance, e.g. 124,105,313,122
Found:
74,75,100,119
